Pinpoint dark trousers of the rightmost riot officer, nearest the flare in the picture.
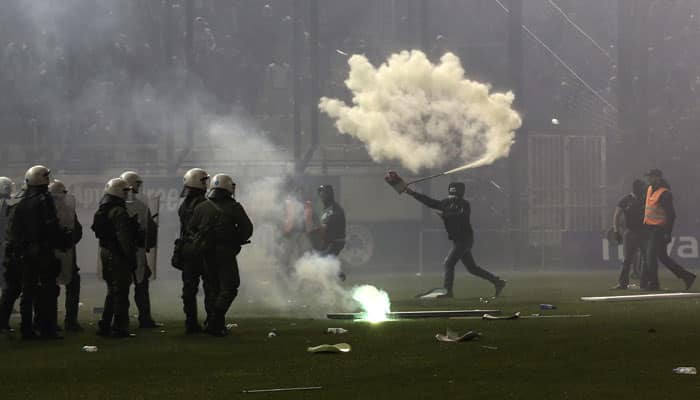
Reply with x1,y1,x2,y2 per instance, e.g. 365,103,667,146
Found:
204,247,241,329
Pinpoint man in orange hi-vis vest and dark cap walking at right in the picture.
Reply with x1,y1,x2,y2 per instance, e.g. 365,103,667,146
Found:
640,169,695,290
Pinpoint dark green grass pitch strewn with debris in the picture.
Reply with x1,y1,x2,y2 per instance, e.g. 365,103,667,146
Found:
0,272,700,400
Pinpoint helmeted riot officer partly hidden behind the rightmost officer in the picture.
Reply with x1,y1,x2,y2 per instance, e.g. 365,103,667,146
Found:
174,168,211,334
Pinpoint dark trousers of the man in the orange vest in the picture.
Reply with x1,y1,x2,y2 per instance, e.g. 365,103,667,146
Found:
640,227,693,290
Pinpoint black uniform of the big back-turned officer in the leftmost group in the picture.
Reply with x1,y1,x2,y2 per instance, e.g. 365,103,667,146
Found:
7,186,65,339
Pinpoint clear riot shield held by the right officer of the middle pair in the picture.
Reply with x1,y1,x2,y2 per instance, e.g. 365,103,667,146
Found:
126,194,160,283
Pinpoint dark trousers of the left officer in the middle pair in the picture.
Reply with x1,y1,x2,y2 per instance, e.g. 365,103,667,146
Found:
99,248,133,332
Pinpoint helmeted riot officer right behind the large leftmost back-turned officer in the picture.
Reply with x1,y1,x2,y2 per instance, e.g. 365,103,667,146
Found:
49,180,83,332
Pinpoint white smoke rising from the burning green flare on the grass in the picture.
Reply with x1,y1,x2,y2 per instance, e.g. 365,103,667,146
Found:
201,114,388,318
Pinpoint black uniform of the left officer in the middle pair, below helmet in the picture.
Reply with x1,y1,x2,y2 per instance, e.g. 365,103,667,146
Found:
92,194,137,337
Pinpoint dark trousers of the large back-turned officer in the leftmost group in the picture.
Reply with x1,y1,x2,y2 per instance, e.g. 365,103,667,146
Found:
19,244,59,336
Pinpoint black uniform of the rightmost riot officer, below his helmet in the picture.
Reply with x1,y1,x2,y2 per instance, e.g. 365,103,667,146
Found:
188,189,253,335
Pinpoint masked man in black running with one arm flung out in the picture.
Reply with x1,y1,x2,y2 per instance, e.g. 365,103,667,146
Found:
409,184,505,296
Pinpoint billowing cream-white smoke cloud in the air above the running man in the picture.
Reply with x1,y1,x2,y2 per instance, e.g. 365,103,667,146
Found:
319,50,521,172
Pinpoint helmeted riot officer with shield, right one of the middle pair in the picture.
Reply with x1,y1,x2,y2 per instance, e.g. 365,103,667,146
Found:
120,171,163,329
